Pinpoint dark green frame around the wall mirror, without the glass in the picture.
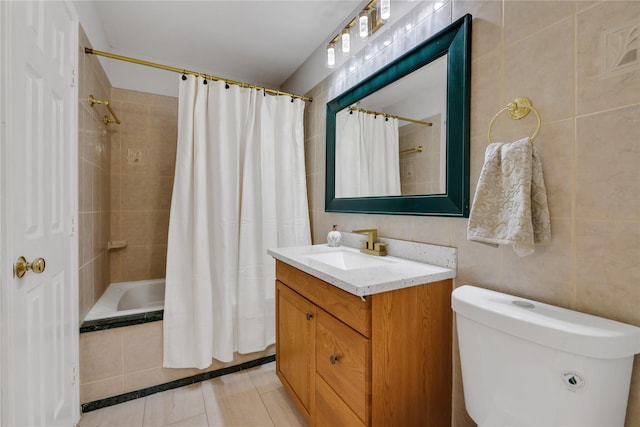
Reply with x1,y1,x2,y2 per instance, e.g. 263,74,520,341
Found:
325,15,471,218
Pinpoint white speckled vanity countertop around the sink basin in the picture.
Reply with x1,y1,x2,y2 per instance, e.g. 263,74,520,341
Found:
267,244,456,296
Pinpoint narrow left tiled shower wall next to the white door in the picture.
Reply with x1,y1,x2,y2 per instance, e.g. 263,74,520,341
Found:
78,25,113,322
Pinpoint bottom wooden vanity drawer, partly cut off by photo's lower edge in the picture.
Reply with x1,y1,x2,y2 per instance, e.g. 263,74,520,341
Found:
315,375,366,427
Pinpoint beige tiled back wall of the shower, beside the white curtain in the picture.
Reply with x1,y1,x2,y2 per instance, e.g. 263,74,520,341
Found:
111,88,178,282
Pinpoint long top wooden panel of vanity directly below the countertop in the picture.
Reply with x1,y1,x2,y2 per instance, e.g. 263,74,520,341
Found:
276,261,371,337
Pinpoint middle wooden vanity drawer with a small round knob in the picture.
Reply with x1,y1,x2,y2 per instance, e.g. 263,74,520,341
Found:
316,309,371,423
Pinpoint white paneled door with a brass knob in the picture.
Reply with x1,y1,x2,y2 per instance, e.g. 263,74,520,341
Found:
0,1,79,427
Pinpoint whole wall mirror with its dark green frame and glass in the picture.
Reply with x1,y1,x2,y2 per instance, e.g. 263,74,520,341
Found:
325,15,471,217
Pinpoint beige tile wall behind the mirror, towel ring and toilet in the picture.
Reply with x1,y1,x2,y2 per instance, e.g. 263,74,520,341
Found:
305,0,640,427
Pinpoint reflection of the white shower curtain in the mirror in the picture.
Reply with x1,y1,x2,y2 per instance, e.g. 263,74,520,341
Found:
335,110,401,198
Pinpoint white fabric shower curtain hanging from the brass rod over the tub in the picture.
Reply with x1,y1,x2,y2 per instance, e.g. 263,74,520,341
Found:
163,76,311,369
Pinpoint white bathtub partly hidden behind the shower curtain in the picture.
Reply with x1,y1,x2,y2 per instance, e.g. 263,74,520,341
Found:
84,279,164,321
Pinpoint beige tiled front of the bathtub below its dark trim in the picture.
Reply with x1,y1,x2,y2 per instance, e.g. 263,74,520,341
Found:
80,321,275,403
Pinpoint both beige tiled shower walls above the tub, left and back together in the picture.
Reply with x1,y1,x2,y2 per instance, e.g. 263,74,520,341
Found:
78,25,178,321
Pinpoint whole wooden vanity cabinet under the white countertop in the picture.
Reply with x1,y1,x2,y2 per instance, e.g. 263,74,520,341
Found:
276,260,452,427
